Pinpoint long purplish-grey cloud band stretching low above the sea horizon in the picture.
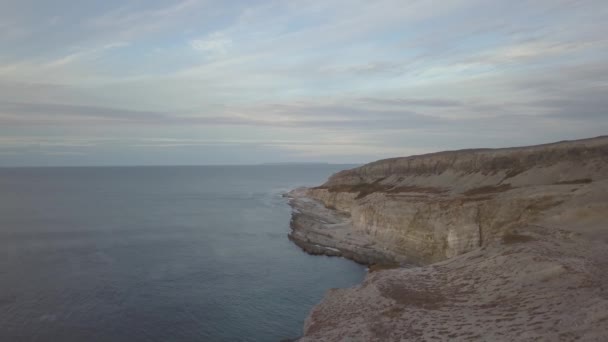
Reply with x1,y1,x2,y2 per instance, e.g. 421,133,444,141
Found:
0,102,440,129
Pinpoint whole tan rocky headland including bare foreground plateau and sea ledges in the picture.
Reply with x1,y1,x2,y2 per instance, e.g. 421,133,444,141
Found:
289,137,608,341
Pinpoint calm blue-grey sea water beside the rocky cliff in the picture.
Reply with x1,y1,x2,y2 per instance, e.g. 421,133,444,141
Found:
0,165,365,341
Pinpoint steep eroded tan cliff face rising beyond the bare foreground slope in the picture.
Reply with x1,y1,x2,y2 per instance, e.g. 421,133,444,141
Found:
296,138,608,264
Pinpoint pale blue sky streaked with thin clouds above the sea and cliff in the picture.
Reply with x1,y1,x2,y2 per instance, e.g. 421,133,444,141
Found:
0,0,608,166
